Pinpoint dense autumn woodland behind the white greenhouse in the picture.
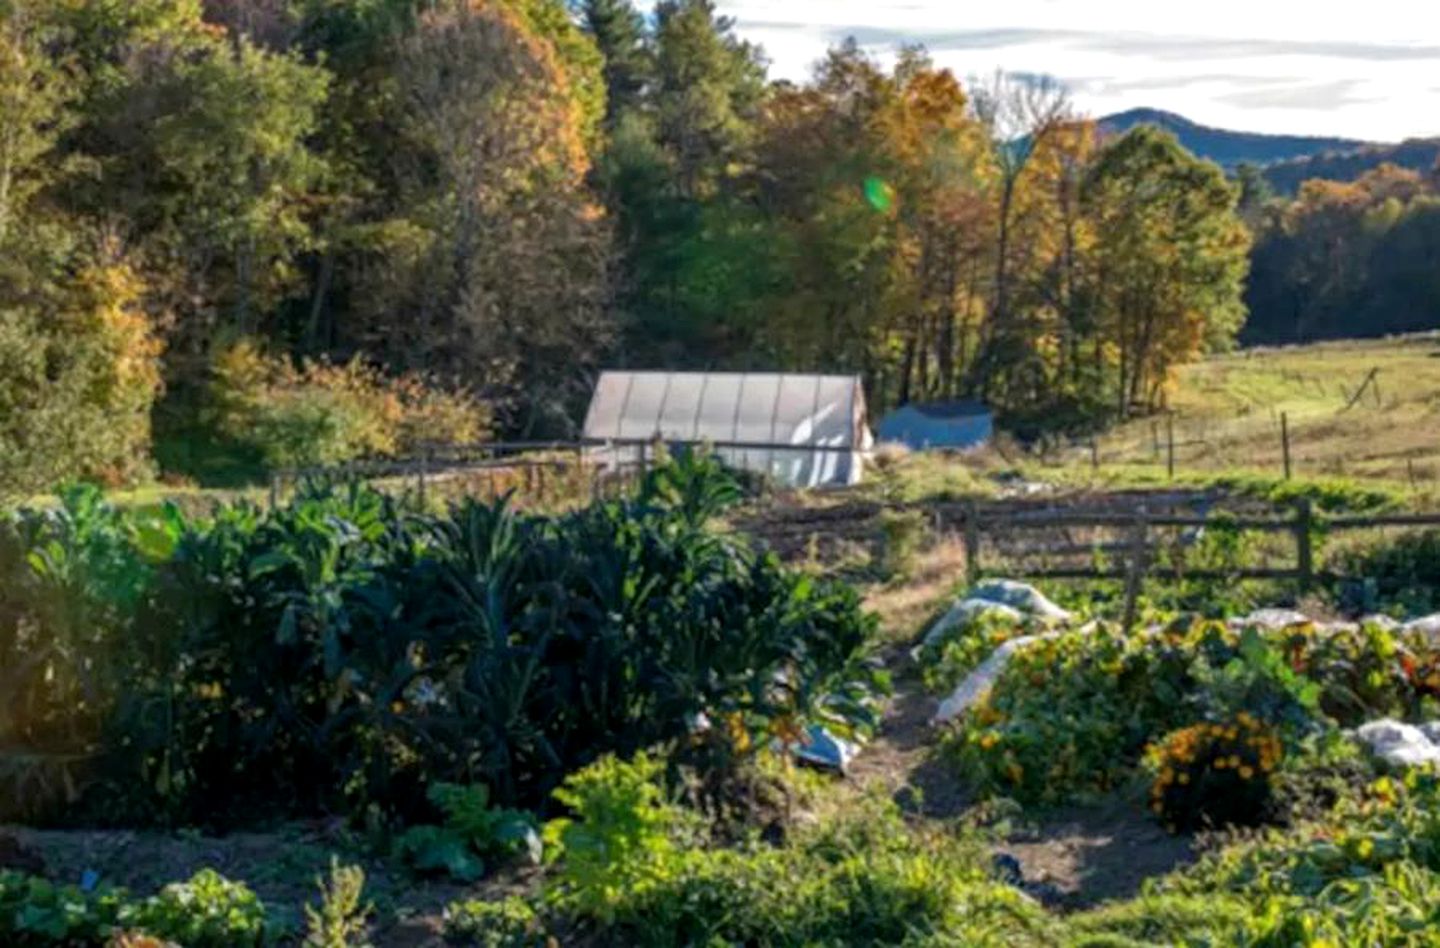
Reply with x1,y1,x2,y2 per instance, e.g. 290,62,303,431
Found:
0,0,1248,487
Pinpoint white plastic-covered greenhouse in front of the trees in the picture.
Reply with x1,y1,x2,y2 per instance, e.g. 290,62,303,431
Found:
585,372,871,487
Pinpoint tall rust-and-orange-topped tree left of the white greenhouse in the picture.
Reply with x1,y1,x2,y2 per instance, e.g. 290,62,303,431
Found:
351,3,609,434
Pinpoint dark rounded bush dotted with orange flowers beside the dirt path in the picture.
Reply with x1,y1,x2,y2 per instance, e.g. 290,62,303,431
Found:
1146,712,1283,830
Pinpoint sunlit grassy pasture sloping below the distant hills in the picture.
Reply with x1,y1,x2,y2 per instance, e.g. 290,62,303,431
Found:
1067,333,1440,488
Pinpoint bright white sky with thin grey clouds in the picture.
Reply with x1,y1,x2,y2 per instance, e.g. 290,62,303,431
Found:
717,0,1440,141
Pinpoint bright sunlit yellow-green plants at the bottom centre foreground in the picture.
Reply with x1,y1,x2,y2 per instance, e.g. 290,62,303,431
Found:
524,758,1053,947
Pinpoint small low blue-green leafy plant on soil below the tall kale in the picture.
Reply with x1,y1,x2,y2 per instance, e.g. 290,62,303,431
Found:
397,784,541,882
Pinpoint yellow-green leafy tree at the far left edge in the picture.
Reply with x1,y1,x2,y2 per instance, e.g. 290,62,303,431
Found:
0,3,160,493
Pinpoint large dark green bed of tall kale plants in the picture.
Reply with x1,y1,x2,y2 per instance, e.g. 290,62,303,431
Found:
0,457,886,829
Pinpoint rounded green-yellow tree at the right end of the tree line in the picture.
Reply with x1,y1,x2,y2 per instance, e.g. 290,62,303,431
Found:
1084,125,1250,416
